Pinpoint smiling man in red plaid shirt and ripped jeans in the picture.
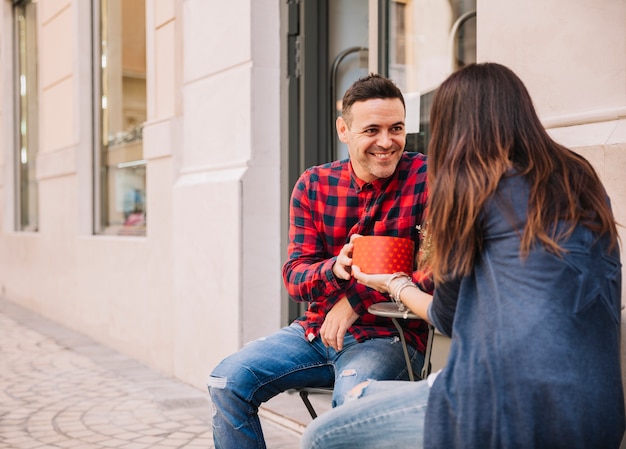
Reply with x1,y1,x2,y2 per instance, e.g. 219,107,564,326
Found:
208,74,427,449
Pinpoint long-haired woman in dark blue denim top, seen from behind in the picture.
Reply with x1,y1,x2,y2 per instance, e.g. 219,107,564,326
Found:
302,63,625,449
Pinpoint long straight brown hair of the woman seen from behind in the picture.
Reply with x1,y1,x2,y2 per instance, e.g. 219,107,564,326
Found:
428,63,617,282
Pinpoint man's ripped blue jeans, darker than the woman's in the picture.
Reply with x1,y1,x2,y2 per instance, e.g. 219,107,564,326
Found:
207,323,424,449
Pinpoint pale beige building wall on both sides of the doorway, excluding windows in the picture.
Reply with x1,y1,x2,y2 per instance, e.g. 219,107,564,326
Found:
0,0,626,388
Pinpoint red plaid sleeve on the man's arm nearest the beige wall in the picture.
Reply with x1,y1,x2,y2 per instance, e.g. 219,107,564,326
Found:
283,172,348,302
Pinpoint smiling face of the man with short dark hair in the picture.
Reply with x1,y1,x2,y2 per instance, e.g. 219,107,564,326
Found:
336,98,406,182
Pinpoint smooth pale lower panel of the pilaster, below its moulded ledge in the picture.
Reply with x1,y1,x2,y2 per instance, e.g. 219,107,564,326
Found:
172,169,243,387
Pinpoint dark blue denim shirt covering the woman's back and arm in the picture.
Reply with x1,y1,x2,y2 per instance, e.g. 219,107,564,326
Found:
425,176,624,448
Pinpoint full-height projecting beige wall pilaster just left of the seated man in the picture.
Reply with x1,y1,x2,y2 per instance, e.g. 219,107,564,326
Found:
173,0,282,382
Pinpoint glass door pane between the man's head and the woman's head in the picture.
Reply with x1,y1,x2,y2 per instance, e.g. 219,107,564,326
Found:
386,0,476,153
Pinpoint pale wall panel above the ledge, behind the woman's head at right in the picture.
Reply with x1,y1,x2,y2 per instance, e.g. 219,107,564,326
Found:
478,0,626,119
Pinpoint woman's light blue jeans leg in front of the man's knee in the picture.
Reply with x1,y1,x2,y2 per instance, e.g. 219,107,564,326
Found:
301,381,430,449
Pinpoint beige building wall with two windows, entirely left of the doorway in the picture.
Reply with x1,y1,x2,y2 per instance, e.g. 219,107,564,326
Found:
0,0,281,388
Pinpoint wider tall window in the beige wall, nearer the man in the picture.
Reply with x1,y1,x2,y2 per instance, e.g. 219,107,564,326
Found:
94,0,146,235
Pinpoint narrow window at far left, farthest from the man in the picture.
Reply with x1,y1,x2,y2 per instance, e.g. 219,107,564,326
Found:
13,0,39,231
